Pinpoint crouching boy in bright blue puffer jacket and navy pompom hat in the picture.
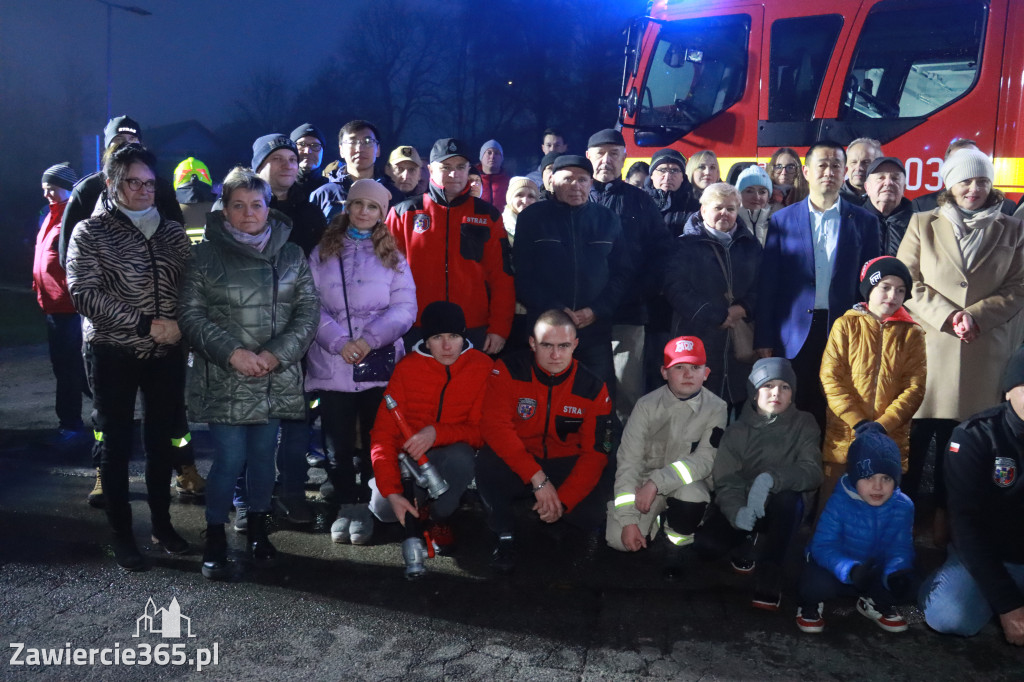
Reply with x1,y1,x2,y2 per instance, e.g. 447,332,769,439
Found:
797,430,920,632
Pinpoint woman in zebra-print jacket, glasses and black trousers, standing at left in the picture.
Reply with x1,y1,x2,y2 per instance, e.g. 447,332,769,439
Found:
68,143,188,570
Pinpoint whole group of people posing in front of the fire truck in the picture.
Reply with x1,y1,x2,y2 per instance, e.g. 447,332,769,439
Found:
29,117,1024,644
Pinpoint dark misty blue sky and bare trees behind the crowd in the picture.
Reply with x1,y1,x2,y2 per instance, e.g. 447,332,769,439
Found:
0,0,646,278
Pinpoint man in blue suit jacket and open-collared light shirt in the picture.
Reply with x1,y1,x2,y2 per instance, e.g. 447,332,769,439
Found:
754,141,882,430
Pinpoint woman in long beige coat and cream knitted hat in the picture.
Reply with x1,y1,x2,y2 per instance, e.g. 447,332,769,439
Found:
898,148,1024,544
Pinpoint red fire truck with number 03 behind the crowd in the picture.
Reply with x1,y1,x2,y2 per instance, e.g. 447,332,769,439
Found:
620,0,1024,199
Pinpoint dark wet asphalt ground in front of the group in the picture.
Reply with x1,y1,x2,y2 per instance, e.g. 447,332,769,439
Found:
0,346,1024,681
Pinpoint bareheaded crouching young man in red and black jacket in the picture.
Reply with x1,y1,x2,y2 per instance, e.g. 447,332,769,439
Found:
476,310,611,572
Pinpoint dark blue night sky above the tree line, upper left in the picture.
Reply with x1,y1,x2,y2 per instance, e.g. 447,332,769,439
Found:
0,0,362,128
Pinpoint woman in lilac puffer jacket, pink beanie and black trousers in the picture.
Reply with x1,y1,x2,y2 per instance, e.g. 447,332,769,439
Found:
306,179,417,544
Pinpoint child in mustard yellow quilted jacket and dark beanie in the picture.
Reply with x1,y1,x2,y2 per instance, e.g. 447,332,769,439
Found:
818,256,927,512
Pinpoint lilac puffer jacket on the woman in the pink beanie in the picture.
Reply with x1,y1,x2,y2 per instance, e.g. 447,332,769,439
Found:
306,238,416,393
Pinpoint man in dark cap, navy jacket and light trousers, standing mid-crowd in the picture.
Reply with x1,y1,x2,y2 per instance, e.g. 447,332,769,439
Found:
587,128,671,422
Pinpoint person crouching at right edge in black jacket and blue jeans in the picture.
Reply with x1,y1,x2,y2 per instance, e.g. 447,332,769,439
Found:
921,349,1024,646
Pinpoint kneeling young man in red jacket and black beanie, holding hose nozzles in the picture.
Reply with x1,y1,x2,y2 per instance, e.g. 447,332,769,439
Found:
370,301,494,550
